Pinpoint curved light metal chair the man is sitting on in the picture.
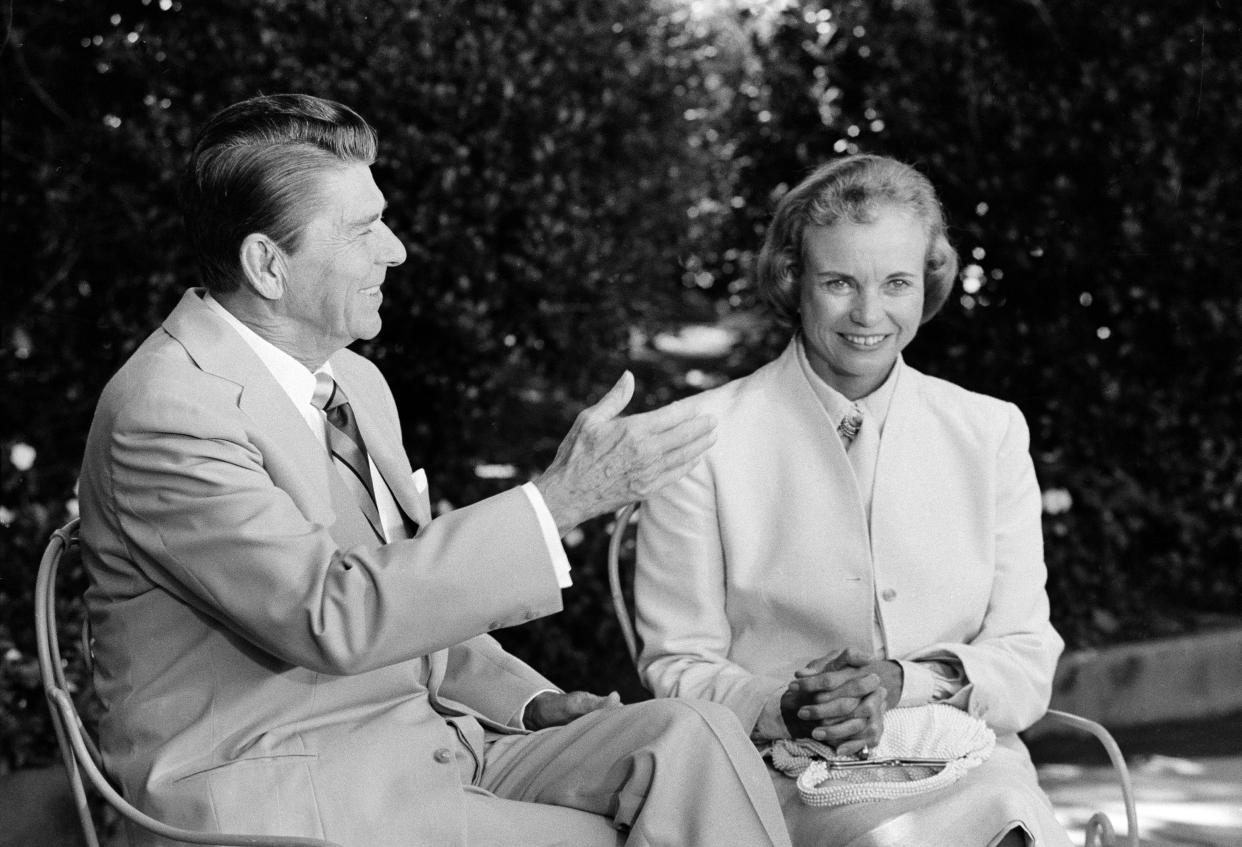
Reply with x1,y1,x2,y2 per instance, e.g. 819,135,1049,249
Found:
35,519,340,847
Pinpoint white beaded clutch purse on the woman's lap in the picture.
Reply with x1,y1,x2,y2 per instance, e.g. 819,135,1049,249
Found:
769,703,996,806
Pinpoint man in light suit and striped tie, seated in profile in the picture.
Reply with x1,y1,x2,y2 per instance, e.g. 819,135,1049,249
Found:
81,94,789,847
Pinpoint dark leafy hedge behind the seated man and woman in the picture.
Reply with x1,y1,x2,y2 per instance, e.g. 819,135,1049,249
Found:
0,0,1242,770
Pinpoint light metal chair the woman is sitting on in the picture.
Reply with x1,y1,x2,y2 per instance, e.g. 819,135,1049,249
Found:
609,503,1139,847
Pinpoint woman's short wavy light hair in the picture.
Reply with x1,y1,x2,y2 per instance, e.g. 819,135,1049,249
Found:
756,154,958,325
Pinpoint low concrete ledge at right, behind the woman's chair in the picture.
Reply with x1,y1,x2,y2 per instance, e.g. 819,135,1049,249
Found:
1052,628,1242,728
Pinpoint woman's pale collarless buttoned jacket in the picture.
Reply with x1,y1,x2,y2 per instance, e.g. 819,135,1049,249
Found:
635,340,1063,733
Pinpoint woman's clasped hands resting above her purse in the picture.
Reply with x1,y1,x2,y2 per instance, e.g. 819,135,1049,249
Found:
781,648,903,756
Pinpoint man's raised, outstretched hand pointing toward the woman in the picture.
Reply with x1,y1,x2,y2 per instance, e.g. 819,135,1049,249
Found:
534,370,715,535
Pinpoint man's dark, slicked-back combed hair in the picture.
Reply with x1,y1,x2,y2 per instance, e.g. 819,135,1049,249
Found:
181,94,378,293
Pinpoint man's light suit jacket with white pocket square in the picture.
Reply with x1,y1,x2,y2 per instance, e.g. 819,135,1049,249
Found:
81,291,560,847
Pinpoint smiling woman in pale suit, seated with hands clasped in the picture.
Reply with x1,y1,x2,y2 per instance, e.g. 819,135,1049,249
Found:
635,155,1069,847
